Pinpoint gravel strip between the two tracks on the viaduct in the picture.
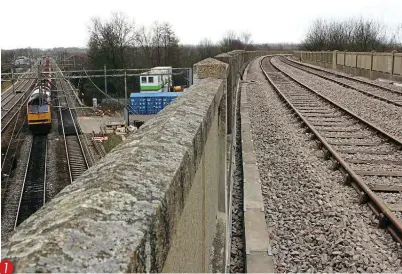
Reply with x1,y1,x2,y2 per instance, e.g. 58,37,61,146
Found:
273,59,402,139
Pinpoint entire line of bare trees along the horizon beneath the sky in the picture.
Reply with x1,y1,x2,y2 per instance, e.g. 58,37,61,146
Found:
7,13,402,104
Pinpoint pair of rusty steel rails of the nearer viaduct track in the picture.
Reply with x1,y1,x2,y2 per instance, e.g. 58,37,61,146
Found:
260,54,402,243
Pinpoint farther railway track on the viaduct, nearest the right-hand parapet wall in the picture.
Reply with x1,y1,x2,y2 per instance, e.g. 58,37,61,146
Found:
279,57,402,107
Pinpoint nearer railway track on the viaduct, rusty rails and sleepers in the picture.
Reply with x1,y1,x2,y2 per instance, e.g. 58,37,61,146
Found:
260,57,402,243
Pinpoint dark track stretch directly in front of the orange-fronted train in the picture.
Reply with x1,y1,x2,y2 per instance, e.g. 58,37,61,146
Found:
14,135,47,228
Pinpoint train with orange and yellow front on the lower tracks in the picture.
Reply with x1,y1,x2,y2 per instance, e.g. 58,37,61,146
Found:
26,56,54,134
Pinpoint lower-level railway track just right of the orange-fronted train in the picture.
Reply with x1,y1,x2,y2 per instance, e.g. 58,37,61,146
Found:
57,76,90,183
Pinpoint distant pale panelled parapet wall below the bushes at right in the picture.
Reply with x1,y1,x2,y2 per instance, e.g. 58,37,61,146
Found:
293,50,402,82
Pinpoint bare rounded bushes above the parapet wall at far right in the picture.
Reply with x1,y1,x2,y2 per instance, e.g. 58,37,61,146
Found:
302,18,402,52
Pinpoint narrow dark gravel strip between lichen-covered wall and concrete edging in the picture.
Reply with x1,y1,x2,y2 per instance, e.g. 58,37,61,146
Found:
230,78,246,273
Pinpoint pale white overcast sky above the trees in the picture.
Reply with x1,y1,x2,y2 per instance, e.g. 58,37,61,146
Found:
0,0,402,49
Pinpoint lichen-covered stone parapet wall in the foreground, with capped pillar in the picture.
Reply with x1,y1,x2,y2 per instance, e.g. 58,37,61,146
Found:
2,51,286,272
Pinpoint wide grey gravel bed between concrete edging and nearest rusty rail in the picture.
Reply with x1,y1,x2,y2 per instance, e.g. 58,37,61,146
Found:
247,56,402,273
